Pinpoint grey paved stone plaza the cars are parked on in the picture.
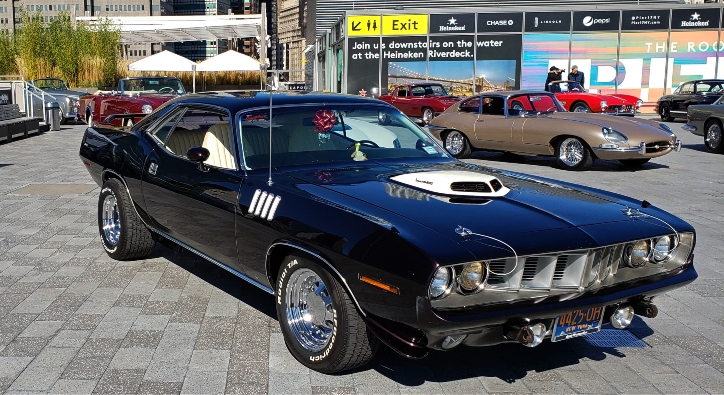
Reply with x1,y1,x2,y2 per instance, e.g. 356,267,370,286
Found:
0,122,724,394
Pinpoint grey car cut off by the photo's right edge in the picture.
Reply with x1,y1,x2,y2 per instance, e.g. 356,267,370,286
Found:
681,96,724,154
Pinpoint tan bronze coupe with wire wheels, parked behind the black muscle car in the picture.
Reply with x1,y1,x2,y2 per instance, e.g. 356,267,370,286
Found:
430,91,681,170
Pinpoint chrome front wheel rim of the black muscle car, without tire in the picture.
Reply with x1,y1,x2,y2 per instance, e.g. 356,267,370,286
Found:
285,268,335,352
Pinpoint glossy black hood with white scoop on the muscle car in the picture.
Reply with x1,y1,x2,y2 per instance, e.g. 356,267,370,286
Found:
287,161,675,259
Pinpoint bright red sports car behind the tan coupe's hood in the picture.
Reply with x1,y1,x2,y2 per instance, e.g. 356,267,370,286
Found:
548,81,643,116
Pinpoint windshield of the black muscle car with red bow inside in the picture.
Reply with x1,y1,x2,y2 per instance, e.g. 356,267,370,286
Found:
238,104,449,170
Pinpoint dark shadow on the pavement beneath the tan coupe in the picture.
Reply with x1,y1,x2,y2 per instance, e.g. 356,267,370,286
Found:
469,151,669,172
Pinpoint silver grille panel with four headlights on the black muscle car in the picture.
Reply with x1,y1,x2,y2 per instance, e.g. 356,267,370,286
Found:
429,233,694,310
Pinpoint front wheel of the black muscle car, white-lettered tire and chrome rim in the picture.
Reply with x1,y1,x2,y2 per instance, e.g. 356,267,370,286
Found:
276,255,380,373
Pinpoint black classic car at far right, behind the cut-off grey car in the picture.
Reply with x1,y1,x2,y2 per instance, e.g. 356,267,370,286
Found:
655,79,724,122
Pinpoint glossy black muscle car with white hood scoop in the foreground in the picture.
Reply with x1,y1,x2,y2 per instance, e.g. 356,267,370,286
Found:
80,92,697,373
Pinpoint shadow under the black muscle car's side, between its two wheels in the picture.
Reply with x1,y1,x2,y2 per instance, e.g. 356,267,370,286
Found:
148,243,277,319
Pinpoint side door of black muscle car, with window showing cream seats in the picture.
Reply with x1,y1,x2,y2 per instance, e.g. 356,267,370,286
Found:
143,103,243,270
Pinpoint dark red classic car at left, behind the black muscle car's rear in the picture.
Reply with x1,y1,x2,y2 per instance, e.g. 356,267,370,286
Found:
78,77,186,127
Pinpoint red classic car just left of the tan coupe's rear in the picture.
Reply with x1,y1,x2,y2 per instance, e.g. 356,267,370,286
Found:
378,82,460,125
